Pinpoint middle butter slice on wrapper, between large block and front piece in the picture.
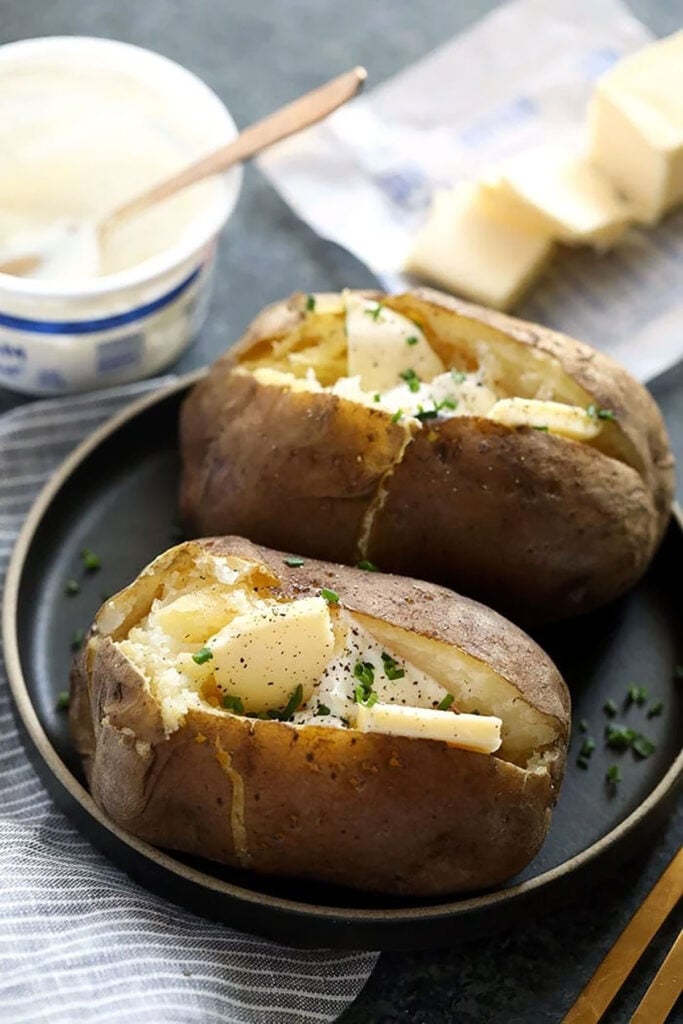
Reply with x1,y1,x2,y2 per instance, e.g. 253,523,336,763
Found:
481,150,636,249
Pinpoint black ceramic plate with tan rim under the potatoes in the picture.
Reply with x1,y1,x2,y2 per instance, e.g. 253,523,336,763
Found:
4,378,683,948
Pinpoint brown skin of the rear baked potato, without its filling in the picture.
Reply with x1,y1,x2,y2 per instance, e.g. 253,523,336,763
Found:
180,289,674,623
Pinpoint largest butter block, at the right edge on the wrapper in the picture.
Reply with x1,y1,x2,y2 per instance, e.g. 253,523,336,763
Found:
589,32,683,223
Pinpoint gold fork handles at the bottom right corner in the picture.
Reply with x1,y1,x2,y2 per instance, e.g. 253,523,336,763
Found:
562,847,683,1024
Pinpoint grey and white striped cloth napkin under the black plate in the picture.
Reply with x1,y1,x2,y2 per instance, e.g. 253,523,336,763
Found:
0,381,377,1024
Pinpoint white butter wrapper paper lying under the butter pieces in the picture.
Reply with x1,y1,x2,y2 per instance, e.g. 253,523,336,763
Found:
260,0,683,380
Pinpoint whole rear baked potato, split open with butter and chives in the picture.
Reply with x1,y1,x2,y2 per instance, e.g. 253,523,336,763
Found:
180,289,674,623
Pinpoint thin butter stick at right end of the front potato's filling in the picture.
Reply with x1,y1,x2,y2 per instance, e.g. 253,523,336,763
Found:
355,702,503,754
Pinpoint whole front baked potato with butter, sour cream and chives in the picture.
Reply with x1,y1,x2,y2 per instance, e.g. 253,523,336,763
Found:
70,538,569,896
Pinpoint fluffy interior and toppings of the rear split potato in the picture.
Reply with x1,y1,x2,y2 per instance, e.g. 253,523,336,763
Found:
241,292,638,468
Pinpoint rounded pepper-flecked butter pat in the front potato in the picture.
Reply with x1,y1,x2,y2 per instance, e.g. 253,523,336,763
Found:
207,597,335,712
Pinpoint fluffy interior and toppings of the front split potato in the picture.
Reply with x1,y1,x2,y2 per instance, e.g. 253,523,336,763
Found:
109,552,554,766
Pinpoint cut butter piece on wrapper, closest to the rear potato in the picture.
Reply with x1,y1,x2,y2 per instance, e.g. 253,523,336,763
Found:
405,184,552,309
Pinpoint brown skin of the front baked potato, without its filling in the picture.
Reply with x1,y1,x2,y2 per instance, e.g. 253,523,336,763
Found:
70,538,569,896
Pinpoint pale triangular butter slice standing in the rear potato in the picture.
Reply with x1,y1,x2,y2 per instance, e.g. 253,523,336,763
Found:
344,292,445,392
